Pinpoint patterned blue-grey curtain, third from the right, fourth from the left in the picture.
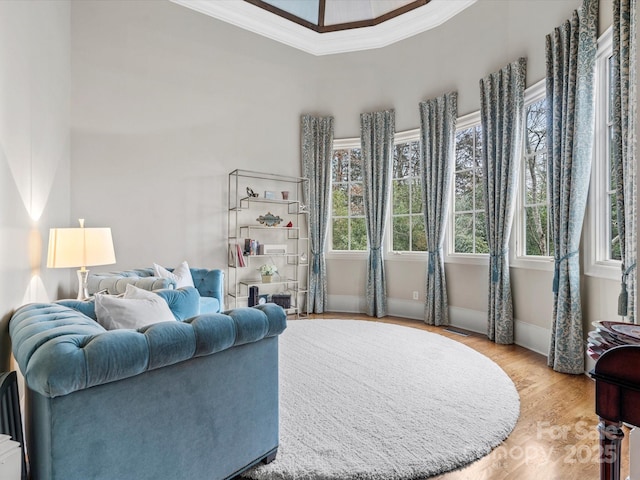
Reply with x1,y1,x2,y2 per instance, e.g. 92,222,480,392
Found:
480,58,527,344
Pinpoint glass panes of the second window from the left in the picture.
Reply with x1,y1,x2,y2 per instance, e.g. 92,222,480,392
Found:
391,136,427,252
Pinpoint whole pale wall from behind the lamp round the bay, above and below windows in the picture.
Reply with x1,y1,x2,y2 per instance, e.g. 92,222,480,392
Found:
71,0,617,350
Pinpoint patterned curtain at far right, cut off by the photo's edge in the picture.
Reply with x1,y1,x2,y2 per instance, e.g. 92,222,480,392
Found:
611,0,637,322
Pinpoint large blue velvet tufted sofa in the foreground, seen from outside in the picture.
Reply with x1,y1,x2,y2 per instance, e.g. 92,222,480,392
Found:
9,288,286,480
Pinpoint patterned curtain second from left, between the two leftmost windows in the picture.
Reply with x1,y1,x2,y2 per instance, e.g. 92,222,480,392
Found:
360,110,395,318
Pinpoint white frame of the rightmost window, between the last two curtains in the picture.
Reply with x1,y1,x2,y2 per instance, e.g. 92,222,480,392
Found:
583,27,622,280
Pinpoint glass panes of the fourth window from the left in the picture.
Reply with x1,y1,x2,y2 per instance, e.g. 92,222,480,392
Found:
518,90,553,257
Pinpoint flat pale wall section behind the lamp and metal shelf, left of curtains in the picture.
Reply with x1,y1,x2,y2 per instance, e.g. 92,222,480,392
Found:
71,1,316,269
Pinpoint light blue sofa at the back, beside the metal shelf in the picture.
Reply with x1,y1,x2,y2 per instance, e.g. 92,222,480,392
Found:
87,268,224,313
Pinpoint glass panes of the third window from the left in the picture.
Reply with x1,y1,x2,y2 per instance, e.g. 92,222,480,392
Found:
450,115,489,254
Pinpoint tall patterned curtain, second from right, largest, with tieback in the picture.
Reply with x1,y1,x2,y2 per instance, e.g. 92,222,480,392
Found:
546,0,598,374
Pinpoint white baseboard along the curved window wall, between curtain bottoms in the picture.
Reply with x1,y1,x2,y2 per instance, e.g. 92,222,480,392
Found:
328,295,551,357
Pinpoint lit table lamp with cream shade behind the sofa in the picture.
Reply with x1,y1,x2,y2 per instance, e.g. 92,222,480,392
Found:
47,218,116,300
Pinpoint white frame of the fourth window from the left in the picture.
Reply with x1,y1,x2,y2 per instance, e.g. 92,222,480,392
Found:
509,78,555,271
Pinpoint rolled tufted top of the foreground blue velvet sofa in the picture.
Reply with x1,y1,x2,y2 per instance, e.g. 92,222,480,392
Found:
9,303,286,397
